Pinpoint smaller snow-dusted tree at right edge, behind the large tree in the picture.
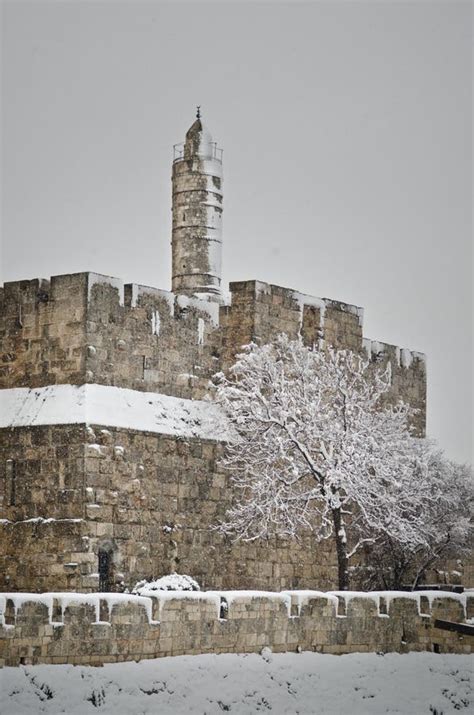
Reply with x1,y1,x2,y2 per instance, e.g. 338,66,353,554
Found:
365,454,474,589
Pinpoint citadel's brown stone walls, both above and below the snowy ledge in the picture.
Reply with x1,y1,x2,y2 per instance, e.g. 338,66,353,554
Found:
0,273,426,591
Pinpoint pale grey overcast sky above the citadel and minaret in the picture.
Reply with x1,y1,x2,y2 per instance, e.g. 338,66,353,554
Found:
2,0,473,461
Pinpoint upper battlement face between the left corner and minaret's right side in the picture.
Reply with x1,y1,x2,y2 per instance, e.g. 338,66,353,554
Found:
85,272,226,399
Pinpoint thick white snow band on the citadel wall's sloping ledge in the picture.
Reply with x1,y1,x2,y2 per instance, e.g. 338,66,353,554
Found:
0,385,225,440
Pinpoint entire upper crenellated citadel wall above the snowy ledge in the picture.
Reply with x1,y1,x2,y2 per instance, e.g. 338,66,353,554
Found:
0,273,426,433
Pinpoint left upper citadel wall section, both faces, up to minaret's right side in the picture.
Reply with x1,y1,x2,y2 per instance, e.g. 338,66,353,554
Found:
0,273,226,397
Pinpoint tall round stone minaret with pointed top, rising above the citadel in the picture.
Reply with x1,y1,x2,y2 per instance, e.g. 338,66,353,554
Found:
171,107,222,302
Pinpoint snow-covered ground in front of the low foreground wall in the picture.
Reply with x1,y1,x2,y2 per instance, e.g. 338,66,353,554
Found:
0,652,474,715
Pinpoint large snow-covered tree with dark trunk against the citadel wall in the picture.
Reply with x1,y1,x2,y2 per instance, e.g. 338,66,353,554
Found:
216,335,436,589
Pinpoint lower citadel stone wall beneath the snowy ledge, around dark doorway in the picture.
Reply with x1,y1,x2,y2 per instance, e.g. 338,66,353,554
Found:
0,425,337,591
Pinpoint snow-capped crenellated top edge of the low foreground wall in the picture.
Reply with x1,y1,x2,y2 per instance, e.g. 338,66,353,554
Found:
0,590,474,625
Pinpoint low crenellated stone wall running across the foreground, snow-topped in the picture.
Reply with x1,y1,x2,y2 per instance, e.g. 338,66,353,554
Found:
0,591,474,666
